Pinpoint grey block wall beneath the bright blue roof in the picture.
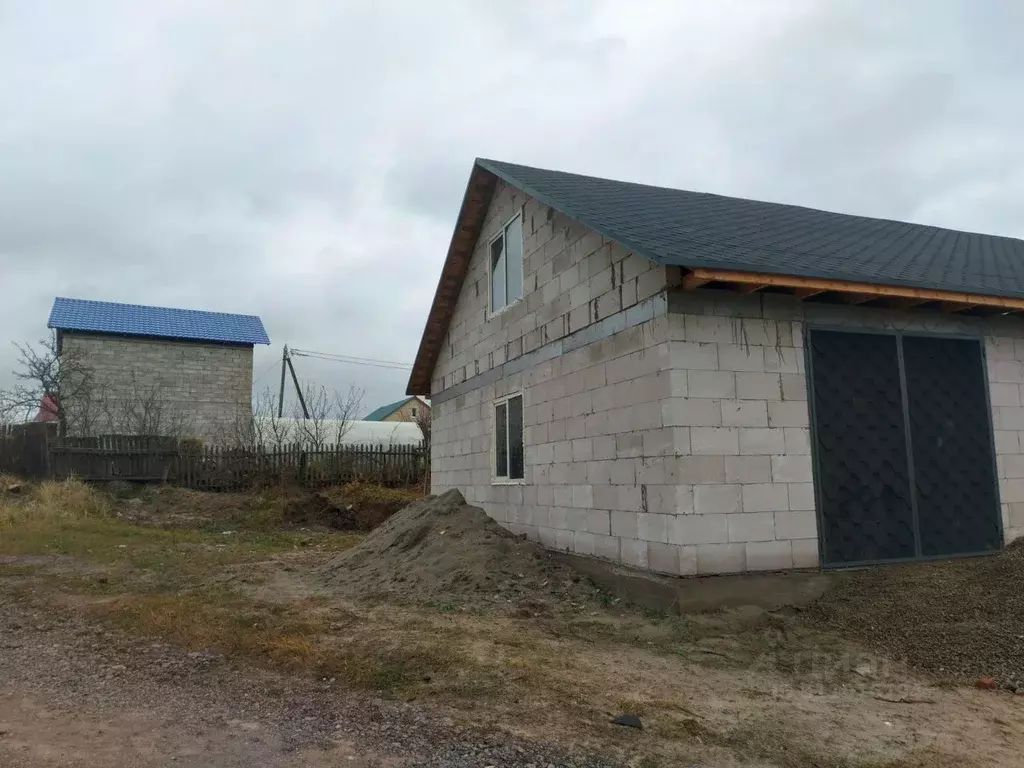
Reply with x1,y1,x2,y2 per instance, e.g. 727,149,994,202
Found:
61,333,253,443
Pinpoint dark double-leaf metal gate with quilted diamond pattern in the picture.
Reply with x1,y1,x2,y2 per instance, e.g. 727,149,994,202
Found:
808,330,1002,565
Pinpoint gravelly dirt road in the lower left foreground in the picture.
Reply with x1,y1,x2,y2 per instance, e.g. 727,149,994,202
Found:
0,597,601,768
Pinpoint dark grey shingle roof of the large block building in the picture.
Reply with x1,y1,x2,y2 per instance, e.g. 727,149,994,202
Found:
477,160,1024,298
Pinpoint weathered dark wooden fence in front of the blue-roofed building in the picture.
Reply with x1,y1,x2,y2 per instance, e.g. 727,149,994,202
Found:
11,435,427,490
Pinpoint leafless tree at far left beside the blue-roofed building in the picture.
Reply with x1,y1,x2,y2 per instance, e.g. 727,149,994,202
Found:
0,334,96,437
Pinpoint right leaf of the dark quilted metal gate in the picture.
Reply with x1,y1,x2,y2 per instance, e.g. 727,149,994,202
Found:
902,336,1001,557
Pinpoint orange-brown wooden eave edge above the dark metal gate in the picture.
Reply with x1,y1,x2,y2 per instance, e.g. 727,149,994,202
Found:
682,268,1024,311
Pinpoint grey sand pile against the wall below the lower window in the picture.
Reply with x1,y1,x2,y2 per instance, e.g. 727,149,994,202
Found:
318,490,599,610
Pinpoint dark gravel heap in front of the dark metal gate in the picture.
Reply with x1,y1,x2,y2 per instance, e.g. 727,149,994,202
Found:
805,541,1024,688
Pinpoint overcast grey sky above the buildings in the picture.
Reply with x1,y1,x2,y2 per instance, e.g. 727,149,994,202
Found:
0,0,1024,410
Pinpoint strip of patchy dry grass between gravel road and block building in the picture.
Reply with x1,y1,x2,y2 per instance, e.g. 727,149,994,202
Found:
0,482,1007,768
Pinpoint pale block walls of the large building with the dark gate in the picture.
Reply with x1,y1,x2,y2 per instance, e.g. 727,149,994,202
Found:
432,186,1024,574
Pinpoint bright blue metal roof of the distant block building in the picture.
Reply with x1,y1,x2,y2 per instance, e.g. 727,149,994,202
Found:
46,297,270,344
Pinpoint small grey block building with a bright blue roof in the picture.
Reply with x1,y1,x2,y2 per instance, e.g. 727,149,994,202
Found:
47,297,270,444
